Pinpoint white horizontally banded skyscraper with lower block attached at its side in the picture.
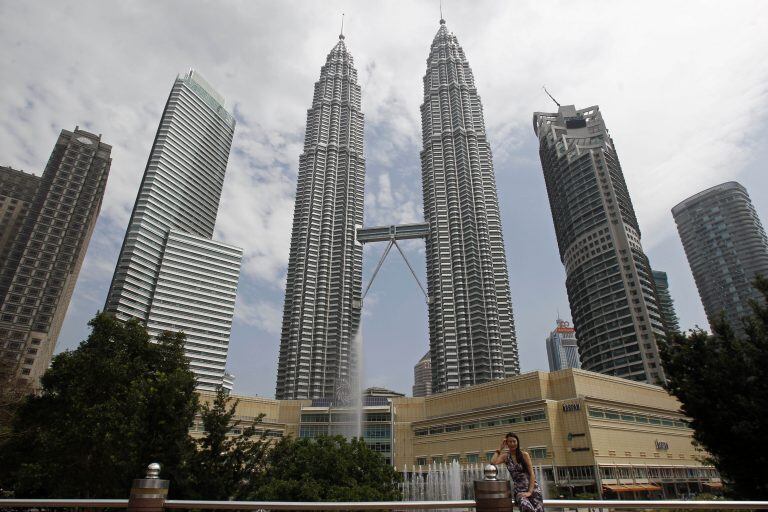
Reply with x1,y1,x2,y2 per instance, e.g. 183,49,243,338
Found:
105,71,242,390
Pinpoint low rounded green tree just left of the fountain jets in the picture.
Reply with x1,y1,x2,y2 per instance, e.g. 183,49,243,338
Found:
251,436,402,501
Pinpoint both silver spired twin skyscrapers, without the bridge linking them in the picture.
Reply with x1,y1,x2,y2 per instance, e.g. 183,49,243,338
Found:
276,20,519,399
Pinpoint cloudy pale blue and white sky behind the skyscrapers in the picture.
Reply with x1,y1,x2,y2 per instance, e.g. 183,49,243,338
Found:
0,0,768,397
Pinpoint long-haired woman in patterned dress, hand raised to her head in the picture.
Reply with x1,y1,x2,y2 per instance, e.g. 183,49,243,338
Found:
491,432,544,512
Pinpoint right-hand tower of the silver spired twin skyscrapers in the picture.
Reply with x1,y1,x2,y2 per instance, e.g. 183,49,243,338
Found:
421,20,520,393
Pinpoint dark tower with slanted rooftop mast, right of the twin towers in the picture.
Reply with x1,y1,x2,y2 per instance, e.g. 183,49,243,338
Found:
533,105,665,383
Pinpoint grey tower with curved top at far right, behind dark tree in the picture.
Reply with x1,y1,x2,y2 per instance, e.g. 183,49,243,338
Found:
672,181,768,335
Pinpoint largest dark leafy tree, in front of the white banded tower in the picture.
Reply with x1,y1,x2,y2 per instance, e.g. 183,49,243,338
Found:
0,314,197,498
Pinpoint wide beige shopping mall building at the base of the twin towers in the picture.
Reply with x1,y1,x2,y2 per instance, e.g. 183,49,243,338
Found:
193,369,722,498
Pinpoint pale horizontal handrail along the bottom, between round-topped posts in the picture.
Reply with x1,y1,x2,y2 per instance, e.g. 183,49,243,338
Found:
0,499,768,510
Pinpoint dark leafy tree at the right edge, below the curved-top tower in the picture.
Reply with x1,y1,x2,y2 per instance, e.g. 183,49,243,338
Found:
662,276,768,499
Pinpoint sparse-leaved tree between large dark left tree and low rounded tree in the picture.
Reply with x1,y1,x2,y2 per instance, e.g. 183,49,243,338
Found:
182,388,270,500
